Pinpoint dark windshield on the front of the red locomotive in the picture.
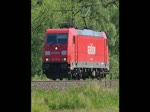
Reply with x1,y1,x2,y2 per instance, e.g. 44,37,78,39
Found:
47,34,68,44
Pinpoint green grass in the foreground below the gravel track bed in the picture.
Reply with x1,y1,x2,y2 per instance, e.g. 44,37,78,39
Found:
31,82,119,112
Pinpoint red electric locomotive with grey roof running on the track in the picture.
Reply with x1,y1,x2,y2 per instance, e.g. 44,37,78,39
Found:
43,28,109,80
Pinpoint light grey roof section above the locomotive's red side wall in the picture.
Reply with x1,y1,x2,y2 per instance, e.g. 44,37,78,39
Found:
75,29,103,38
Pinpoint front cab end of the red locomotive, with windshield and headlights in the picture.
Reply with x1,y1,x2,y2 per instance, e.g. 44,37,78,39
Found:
43,29,68,80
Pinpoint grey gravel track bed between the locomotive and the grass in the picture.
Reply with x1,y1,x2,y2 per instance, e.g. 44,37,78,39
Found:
31,80,119,91
